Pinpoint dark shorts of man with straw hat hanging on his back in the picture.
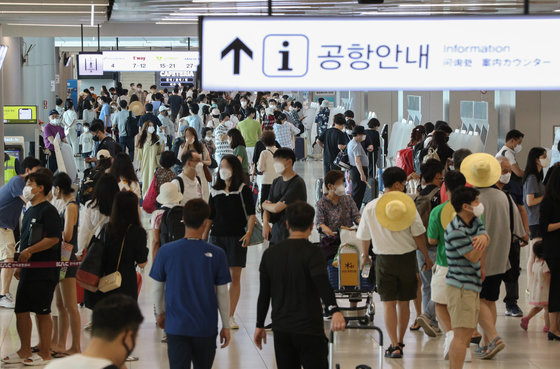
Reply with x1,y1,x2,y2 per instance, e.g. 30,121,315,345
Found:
375,251,418,301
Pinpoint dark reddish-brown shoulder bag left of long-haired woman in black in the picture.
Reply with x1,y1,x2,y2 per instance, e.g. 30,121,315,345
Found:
76,217,105,292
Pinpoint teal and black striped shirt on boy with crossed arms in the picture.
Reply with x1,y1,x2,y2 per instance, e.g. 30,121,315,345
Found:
445,215,486,292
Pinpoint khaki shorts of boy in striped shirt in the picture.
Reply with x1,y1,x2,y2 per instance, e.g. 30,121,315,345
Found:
446,285,480,329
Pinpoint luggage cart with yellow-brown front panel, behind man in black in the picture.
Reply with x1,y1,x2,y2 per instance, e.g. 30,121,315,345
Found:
334,245,375,325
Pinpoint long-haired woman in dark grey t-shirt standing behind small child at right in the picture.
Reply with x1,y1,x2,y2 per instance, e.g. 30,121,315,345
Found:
522,147,550,286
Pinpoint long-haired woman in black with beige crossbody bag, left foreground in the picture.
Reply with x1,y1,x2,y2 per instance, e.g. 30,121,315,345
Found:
96,191,148,302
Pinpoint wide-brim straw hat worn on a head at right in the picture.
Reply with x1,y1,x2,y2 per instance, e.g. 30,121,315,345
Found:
461,153,502,187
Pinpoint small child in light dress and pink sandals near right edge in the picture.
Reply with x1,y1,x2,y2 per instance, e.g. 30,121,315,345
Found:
521,241,550,333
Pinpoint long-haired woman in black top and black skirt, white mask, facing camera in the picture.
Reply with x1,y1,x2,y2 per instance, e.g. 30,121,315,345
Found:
204,155,256,329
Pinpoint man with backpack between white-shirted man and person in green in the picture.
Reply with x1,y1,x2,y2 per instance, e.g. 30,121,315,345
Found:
414,159,444,337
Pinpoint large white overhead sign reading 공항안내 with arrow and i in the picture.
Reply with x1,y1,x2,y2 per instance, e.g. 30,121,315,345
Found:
200,16,560,91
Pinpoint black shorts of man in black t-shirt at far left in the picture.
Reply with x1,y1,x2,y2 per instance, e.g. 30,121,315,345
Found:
15,281,58,315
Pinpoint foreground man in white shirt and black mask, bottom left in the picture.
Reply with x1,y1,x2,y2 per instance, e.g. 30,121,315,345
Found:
45,294,144,369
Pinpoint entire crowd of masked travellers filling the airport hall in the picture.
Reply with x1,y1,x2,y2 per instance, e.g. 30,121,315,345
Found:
0,84,560,369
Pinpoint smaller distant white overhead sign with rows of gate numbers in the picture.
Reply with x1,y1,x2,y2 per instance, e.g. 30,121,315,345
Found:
103,51,199,72
